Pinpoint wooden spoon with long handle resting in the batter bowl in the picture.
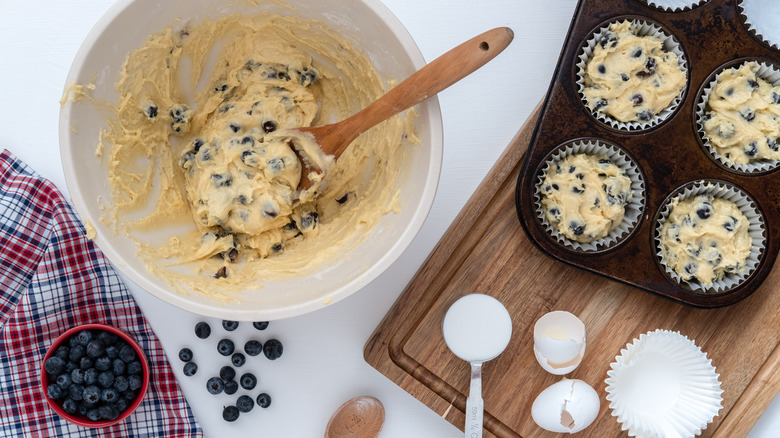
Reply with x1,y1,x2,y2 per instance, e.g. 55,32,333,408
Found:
296,27,514,190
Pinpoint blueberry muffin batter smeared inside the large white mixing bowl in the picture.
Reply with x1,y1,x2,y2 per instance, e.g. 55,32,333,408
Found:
90,14,417,300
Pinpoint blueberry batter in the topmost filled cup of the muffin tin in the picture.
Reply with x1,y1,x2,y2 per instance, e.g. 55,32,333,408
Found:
584,21,686,122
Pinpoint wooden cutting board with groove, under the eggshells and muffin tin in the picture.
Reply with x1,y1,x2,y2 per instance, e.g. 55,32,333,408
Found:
364,103,780,438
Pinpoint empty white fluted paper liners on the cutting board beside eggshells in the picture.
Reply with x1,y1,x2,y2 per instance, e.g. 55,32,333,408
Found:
605,330,723,438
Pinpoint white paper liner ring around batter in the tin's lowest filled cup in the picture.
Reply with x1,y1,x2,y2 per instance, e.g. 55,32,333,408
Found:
654,181,766,294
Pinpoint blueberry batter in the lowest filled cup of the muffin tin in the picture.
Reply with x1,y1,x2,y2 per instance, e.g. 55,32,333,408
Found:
661,194,752,285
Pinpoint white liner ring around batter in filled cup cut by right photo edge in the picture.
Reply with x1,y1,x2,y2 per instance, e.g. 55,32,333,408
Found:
696,61,780,173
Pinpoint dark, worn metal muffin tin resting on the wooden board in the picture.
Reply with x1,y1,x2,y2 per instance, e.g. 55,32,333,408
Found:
516,0,780,308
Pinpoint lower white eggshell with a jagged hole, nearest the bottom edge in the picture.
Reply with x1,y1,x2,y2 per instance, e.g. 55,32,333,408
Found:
531,379,601,433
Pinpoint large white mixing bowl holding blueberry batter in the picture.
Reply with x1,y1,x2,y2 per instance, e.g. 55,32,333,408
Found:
60,0,443,321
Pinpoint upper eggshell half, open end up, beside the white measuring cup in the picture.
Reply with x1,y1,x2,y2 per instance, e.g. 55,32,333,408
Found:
534,311,586,375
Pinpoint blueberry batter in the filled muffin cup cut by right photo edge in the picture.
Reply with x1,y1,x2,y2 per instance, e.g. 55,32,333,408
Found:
704,62,780,164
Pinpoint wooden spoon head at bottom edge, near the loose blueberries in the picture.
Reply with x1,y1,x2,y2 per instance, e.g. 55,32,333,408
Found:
325,396,385,438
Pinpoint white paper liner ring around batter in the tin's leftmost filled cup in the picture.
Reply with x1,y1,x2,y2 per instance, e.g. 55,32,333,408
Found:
534,139,645,252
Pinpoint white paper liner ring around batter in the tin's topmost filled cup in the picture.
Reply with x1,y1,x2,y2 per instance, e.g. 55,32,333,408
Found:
576,19,688,132
